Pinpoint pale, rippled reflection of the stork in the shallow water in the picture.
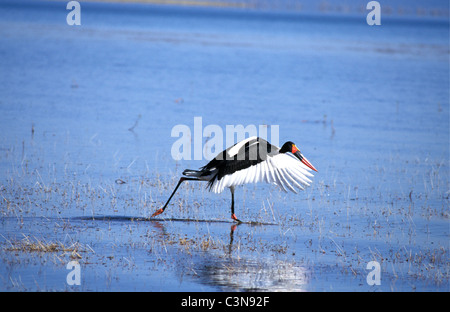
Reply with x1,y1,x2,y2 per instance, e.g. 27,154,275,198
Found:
149,222,309,291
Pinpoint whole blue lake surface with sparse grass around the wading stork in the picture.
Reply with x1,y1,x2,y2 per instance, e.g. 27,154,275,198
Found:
0,1,450,291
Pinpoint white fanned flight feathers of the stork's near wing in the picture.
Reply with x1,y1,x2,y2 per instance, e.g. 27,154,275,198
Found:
211,153,313,193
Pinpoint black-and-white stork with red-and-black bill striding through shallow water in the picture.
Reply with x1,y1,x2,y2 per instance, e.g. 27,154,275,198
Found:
151,136,318,223
